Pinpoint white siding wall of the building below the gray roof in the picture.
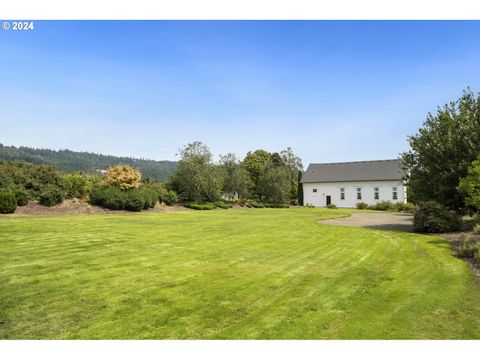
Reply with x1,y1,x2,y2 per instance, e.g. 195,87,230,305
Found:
303,181,407,208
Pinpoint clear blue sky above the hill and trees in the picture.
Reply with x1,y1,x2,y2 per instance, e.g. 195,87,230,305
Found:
0,21,480,165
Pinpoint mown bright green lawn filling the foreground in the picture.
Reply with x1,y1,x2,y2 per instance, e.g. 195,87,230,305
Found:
0,209,480,339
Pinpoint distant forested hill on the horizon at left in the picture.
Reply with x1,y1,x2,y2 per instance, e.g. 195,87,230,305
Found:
0,144,177,181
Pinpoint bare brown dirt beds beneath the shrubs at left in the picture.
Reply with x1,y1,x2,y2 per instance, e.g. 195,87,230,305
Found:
0,199,191,216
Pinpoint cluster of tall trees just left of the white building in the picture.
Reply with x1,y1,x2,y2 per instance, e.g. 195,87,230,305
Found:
167,141,303,205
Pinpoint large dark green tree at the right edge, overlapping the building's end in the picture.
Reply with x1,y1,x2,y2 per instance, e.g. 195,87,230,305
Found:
402,89,480,210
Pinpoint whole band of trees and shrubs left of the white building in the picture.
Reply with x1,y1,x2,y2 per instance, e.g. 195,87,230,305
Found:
0,142,303,213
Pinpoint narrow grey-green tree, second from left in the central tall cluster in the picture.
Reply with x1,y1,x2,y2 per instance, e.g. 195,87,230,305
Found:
220,153,250,199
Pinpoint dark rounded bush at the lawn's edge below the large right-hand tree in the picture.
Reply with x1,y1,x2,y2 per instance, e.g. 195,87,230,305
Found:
413,201,461,233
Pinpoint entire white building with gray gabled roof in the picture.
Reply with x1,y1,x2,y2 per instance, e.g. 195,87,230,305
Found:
302,160,407,208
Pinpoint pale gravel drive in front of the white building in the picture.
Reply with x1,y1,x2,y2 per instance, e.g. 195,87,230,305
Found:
319,212,413,231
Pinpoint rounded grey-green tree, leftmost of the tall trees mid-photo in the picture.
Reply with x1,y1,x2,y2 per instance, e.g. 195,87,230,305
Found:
170,141,223,202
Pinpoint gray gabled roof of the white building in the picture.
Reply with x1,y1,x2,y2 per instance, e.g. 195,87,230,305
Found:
302,159,404,183
